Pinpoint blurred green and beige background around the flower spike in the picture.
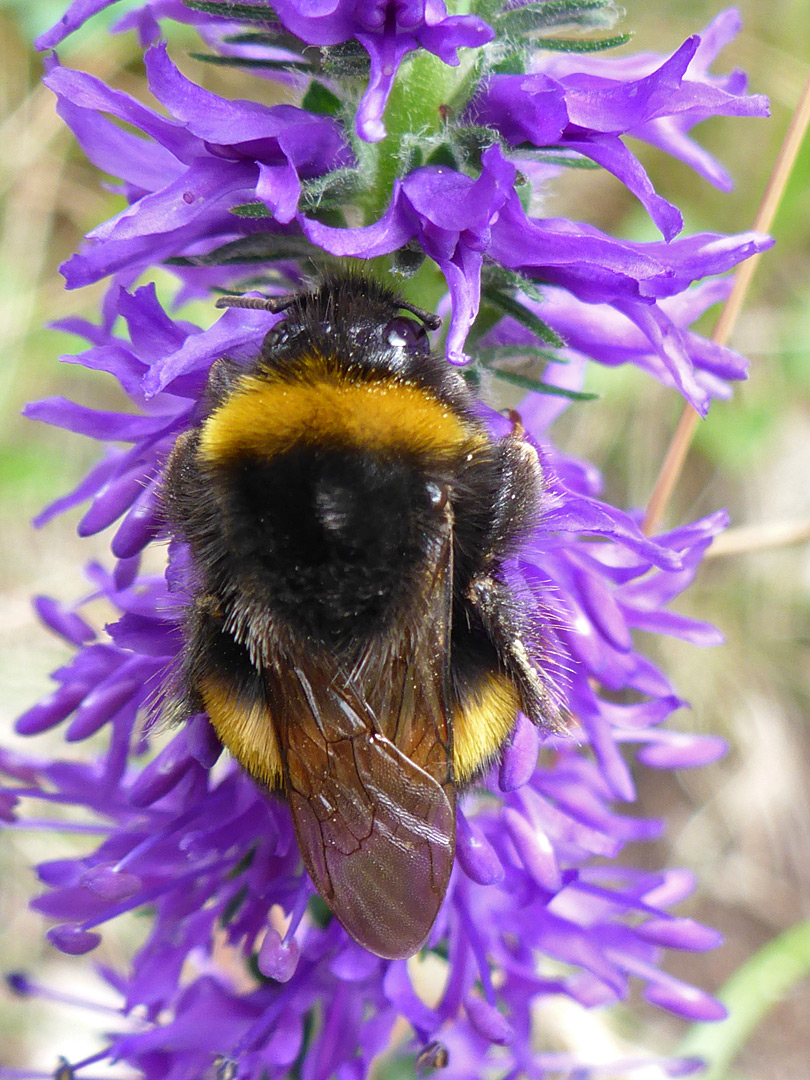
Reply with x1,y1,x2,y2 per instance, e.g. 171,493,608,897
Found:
0,0,810,1080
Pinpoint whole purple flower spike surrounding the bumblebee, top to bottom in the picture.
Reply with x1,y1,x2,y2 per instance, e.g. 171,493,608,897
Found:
11,0,768,1080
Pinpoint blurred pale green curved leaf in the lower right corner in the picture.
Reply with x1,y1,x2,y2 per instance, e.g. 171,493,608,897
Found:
678,919,810,1080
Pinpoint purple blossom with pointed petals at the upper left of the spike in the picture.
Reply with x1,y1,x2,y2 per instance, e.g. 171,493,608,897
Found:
44,45,350,287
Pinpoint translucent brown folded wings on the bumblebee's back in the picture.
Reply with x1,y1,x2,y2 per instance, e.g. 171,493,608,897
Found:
266,513,456,958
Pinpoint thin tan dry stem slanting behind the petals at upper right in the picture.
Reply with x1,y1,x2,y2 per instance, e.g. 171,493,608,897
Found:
642,73,810,536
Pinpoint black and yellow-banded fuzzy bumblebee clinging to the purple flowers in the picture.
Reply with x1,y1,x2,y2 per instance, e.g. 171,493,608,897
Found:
163,273,561,958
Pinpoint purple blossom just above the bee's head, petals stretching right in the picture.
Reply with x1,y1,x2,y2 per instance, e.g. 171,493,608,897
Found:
302,146,770,413
